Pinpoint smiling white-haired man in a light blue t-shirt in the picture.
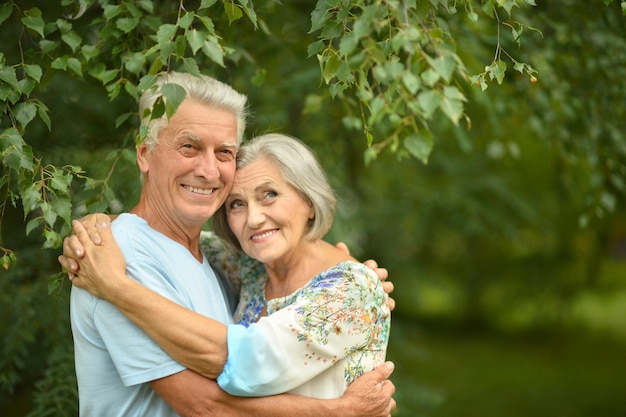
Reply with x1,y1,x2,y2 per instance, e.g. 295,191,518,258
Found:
60,73,395,417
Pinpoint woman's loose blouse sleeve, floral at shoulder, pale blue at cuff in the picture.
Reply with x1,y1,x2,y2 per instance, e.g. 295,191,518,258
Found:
217,269,386,396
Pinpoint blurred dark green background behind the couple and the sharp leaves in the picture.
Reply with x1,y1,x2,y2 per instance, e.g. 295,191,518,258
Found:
0,0,626,417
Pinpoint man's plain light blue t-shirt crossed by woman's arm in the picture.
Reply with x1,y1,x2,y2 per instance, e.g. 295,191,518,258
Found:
70,214,232,417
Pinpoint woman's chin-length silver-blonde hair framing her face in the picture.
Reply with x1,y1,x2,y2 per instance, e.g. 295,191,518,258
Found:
213,133,337,250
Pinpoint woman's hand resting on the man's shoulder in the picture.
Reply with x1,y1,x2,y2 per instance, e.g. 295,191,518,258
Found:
59,220,129,299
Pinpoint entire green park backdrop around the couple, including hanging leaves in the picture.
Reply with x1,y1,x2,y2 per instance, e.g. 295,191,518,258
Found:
0,0,626,417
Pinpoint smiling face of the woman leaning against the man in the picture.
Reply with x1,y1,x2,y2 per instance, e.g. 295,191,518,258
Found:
226,158,315,264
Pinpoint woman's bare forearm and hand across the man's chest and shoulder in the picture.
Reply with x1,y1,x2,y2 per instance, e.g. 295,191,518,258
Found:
59,221,228,378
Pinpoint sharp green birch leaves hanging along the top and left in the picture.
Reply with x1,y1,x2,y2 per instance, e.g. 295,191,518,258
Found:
0,0,535,268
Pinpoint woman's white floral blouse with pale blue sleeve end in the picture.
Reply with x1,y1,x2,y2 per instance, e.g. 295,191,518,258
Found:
201,232,391,398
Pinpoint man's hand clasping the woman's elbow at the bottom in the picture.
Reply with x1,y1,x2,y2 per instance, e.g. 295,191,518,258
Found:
341,362,396,417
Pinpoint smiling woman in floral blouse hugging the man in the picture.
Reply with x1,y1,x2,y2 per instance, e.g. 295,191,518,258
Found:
63,134,390,398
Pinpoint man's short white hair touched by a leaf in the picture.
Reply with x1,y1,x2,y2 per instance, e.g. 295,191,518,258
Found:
139,71,247,151
